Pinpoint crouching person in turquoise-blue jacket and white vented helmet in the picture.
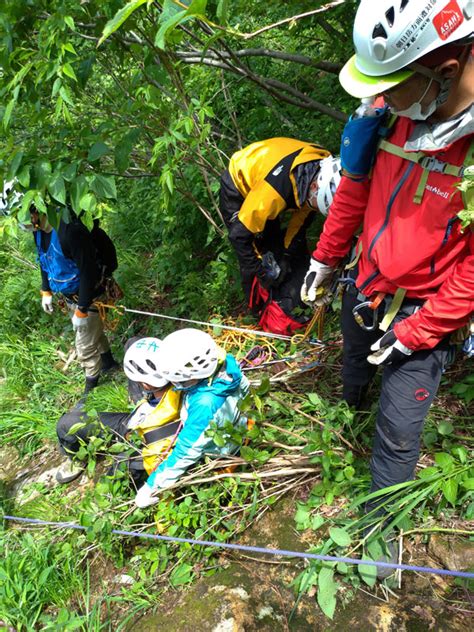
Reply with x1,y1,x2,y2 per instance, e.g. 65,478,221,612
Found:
135,329,249,507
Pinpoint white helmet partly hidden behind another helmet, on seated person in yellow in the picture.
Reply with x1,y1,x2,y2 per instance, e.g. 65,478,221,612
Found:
123,338,168,388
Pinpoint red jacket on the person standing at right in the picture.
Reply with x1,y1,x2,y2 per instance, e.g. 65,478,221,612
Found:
313,117,474,350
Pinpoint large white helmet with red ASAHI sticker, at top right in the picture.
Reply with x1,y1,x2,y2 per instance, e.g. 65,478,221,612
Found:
339,0,474,98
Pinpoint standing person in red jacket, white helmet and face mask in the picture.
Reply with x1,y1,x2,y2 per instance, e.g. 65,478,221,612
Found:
301,0,474,564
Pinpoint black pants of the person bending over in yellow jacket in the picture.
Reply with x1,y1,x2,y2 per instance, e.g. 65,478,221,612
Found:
219,170,315,301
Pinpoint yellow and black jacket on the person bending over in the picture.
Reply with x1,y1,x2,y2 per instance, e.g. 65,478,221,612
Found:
222,138,330,276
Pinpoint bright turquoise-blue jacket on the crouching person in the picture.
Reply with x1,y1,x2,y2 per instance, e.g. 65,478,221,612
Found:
147,355,249,489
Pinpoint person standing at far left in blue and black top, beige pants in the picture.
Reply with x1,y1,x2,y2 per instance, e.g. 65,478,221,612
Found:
30,207,118,393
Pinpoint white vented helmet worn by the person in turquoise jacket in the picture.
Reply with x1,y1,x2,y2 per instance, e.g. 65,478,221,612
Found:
158,328,222,382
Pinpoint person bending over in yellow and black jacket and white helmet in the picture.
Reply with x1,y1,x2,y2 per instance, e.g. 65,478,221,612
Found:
220,138,340,299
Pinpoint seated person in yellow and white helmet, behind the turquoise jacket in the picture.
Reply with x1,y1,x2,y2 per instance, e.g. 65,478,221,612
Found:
56,338,181,486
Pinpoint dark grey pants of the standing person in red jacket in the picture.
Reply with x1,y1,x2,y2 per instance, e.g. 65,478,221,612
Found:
342,289,449,502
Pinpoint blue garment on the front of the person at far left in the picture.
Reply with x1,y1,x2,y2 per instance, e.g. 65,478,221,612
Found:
34,228,79,294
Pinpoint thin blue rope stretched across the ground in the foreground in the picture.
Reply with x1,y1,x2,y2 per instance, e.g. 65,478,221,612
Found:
3,516,474,579
